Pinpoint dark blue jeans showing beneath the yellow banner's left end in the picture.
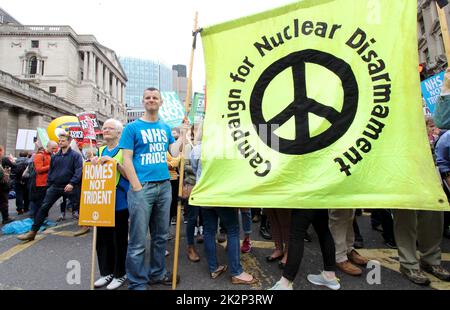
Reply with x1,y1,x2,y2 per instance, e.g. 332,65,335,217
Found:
202,208,243,277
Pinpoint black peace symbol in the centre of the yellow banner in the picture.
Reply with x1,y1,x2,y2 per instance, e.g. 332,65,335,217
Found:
250,49,359,155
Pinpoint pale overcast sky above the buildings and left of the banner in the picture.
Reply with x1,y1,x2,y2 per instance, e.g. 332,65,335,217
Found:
0,0,294,91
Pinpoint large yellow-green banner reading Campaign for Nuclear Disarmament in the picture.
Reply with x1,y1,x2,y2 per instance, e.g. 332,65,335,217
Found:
190,0,448,210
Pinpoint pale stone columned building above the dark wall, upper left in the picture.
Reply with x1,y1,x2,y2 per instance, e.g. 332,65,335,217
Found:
0,24,127,123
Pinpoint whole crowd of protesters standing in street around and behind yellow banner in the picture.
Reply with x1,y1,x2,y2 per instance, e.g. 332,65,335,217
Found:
0,70,450,290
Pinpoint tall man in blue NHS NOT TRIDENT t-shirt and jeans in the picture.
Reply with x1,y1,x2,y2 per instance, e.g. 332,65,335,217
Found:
119,88,185,290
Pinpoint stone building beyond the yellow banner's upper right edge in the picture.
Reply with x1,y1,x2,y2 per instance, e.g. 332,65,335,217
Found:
418,0,450,75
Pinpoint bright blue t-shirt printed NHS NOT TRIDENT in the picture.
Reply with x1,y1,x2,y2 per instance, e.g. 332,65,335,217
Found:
119,119,175,183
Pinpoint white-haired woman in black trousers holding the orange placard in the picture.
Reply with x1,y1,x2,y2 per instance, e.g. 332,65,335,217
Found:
92,119,129,290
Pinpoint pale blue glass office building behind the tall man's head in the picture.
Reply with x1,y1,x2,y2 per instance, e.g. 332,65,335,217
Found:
120,57,173,110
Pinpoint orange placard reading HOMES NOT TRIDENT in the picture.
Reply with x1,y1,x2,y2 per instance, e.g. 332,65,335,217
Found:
78,161,117,227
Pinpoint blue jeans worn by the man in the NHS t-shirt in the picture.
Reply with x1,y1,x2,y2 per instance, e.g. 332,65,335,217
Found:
126,181,172,290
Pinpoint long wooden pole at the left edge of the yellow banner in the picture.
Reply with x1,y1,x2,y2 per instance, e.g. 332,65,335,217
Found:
172,12,198,290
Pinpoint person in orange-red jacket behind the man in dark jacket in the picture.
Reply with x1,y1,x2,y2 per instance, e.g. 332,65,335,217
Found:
28,141,58,218
